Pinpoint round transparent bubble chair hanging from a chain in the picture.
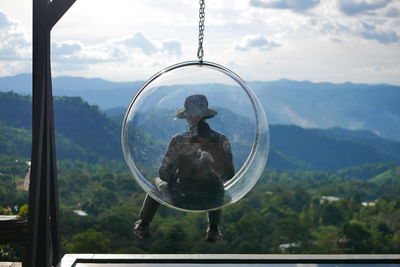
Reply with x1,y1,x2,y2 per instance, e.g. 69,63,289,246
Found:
122,61,269,211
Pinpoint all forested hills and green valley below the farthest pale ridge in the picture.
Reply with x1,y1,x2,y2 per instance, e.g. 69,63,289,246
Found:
0,93,400,260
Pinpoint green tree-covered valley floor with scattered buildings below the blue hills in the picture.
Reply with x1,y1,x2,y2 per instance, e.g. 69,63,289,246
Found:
0,156,400,259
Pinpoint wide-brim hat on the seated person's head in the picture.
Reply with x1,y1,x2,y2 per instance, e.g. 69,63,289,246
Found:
176,94,217,119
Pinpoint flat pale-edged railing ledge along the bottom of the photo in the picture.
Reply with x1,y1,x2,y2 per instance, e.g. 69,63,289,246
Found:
57,254,400,267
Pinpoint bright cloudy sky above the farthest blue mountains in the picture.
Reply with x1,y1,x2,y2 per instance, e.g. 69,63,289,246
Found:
0,0,400,85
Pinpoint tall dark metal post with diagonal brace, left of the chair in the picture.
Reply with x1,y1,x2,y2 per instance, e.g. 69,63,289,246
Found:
27,0,75,267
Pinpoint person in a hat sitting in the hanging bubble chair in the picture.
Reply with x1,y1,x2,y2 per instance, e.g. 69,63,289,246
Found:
133,94,235,242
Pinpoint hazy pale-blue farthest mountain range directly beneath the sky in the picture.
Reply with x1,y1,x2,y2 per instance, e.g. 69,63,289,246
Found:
0,74,400,141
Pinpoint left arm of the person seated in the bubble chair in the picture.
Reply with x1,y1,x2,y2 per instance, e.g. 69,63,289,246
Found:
158,137,180,183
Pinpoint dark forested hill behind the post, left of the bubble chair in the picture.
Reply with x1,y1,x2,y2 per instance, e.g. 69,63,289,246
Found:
0,92,160,162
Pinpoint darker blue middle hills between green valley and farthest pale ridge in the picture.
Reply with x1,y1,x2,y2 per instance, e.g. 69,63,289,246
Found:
0,92,400,170
